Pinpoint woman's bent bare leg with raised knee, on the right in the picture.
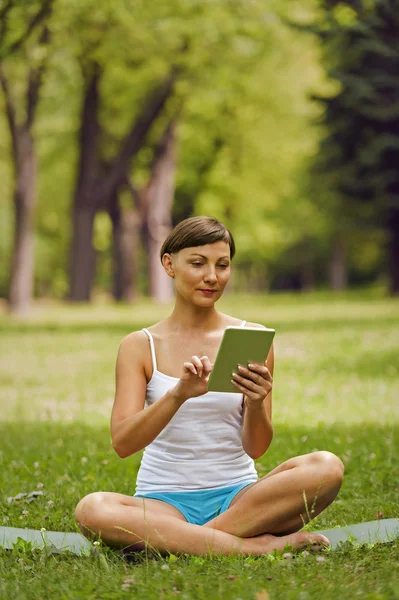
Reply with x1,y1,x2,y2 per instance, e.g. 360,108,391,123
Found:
204,452,344,538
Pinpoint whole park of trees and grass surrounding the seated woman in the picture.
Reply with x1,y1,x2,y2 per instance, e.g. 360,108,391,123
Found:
0,0,399,600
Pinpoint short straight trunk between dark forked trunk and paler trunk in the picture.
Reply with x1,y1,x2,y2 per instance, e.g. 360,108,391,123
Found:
109,197,140,303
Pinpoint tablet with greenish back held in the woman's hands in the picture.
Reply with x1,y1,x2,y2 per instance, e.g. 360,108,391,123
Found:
207,327,275,394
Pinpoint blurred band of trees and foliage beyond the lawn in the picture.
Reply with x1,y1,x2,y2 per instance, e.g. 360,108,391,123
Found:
0,0,399,313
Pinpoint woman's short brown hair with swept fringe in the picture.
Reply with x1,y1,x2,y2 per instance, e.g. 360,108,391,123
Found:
160,217,236,260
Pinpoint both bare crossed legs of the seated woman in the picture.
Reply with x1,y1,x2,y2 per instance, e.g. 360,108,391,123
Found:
75,452,344,555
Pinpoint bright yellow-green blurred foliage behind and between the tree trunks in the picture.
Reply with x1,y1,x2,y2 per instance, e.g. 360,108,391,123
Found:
0,0,395,297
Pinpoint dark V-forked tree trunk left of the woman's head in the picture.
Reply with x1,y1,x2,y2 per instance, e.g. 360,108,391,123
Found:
70,58,175,301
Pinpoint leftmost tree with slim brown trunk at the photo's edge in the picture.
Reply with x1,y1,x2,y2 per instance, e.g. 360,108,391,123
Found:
0,0,52,313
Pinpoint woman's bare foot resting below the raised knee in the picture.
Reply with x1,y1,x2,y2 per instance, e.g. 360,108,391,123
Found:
248,531,330,555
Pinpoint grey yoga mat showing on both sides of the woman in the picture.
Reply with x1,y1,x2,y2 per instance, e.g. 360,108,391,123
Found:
0,519,399,556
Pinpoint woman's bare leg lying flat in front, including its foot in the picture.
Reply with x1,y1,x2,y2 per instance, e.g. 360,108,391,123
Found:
75,492,328,555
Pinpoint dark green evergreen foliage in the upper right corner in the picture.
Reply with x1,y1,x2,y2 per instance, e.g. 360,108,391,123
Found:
314,0,399,209
